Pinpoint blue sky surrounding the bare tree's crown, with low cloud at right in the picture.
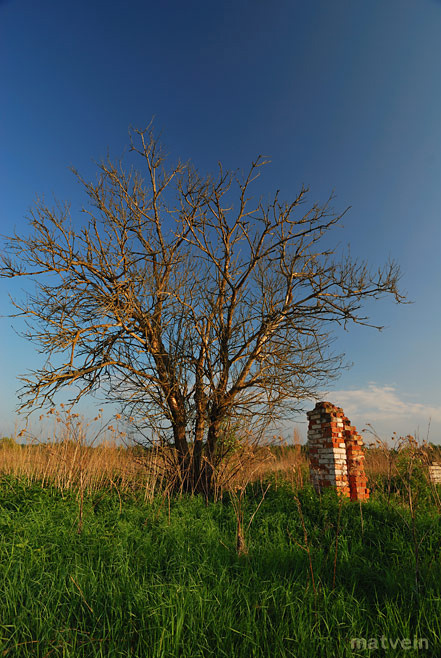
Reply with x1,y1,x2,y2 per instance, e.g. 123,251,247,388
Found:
0,0,441,443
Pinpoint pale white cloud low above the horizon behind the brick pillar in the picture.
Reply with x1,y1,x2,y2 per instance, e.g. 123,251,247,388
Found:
323,382,441,443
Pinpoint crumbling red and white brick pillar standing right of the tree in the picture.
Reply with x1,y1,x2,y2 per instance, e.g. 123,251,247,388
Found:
307,402,369,500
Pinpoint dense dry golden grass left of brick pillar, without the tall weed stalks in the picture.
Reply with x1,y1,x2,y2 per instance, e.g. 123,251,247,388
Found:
0,440,307,498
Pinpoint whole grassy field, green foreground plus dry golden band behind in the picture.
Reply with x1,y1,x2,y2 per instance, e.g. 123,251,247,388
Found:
0,410,441,658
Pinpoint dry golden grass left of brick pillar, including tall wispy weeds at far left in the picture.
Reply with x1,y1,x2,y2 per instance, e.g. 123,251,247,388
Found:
0,406,307,499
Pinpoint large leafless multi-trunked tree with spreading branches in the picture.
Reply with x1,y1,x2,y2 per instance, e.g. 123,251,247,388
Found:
0,128,403,491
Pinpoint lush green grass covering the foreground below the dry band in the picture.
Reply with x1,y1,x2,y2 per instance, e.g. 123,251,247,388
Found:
0,476,441,658
